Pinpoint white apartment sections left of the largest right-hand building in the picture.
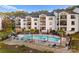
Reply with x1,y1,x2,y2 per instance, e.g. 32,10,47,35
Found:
15,14,57,32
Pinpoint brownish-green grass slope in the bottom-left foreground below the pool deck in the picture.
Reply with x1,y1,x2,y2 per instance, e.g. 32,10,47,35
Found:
0,43,53,53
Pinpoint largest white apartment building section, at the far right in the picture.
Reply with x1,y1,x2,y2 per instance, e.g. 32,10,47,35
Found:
58,11,79,34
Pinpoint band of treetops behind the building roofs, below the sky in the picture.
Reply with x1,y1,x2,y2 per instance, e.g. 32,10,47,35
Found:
0,5,79,17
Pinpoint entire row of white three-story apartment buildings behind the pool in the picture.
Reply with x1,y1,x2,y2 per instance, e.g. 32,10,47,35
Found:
15,10,79,34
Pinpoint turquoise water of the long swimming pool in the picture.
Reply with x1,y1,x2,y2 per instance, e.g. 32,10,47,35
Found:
22,34,60,42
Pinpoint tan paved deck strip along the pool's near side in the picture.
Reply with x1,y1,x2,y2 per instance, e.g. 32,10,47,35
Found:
1,40,72,53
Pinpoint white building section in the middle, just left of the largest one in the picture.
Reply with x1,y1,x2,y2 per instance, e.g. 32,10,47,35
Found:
39,14,57,32
